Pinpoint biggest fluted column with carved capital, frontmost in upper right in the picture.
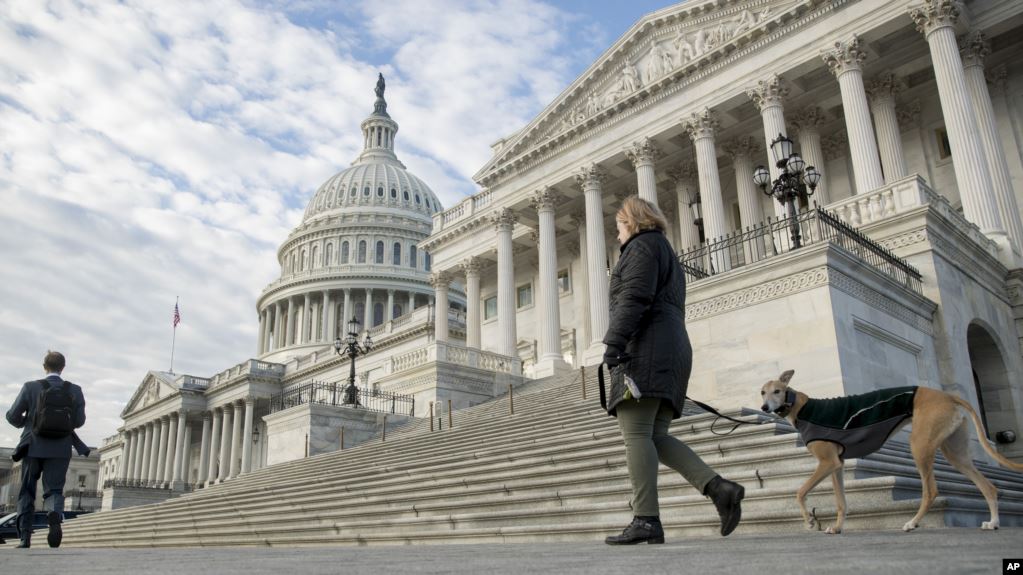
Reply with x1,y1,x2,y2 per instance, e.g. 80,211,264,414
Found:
909,0,1009,240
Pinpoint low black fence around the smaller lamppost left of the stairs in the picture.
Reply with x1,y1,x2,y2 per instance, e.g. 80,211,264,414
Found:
270,382,415,415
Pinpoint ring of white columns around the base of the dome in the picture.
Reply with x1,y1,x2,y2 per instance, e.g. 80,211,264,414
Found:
257,288,429,355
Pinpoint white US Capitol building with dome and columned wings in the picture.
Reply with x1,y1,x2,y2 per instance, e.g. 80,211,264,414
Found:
94,0,1023,508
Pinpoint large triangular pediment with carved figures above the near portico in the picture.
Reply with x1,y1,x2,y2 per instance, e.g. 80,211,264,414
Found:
474,0,821,186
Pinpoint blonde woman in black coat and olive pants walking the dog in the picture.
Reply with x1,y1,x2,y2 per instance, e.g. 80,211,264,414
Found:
604,195,745,545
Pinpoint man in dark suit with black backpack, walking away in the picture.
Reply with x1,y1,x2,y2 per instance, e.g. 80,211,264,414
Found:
7,351,85,548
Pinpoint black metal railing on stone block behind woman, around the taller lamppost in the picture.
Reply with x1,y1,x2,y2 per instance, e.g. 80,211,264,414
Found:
678,208,921,293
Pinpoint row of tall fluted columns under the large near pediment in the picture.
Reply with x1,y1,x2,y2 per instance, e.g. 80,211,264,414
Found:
423,0,1023,359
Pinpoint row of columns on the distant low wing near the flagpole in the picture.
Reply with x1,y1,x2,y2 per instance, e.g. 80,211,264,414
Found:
118,397,256,489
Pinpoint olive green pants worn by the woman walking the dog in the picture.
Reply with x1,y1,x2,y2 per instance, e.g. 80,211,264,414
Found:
616,398,717,517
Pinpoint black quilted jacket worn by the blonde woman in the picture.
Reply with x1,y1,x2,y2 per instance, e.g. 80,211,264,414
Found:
604,230,693,417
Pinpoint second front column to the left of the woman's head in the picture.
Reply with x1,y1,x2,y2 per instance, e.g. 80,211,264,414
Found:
531,188,564,378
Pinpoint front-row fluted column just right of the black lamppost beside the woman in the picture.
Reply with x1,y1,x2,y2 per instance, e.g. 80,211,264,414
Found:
821,36,885,194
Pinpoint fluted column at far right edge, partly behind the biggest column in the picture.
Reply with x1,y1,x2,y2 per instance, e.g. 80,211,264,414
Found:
960,32,1023,252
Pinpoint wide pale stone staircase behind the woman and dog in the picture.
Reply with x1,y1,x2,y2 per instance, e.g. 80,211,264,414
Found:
64,369,1023,546
